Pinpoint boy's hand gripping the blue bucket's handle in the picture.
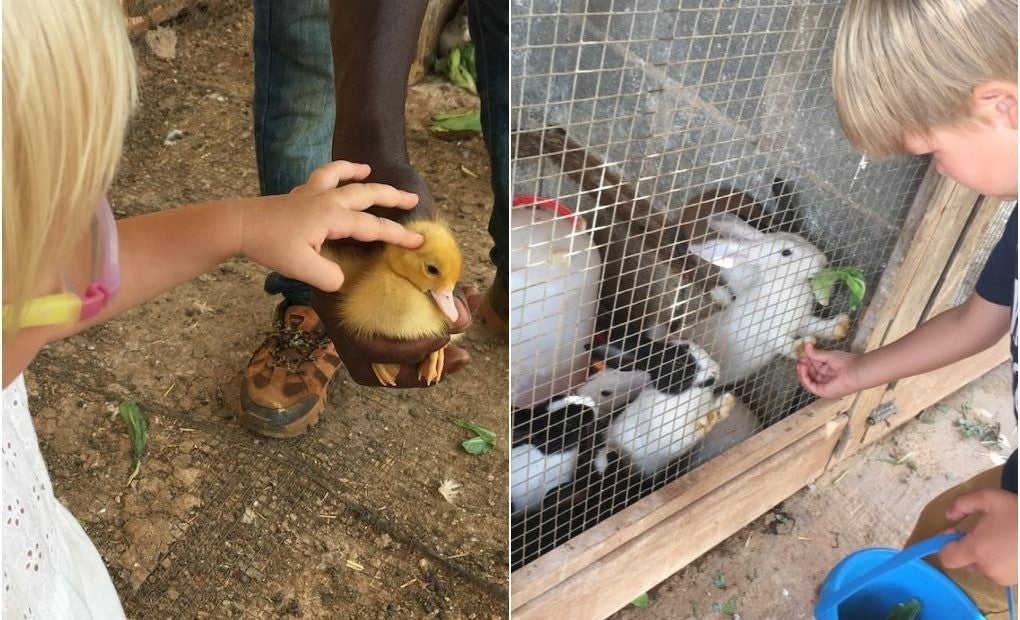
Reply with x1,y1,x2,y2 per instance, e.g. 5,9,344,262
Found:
938,488,1017,585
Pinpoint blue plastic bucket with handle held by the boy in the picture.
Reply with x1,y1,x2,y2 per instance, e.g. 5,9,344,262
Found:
815,533,1012,620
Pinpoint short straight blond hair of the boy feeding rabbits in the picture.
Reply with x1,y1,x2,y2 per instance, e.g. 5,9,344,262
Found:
832,0,1017,157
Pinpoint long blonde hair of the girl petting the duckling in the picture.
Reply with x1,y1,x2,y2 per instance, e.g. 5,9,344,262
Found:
3,0,137,334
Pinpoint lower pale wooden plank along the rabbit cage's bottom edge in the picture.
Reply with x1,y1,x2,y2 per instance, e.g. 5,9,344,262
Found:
511,415,847,620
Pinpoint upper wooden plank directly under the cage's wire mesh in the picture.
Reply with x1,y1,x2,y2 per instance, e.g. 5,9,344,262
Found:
510,401,848,610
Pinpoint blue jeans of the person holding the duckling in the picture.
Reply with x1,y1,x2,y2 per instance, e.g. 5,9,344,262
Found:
254,0,510,305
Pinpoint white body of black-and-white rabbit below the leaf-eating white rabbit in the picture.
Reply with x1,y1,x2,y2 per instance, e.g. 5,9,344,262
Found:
595,344,736,476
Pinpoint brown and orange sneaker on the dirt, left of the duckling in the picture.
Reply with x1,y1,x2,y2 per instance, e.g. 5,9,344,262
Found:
238,304,340,437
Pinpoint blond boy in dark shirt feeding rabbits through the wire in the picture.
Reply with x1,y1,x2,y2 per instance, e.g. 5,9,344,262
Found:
797,0,1017,619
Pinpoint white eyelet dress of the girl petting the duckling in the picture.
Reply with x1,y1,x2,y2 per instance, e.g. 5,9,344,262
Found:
0,375,124,620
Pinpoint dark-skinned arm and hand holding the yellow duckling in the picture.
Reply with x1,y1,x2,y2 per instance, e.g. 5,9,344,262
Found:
312,0,477,388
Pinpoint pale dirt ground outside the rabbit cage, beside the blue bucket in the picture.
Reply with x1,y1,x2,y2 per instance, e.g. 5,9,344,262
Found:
612,363,1017,620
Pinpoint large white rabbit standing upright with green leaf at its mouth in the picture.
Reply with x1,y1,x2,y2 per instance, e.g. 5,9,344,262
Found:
682,213,850,385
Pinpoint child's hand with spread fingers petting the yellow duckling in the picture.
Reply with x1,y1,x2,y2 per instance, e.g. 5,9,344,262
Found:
240,161,423,292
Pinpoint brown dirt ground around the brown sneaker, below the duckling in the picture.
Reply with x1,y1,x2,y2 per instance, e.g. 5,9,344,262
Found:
27,0,508,618
